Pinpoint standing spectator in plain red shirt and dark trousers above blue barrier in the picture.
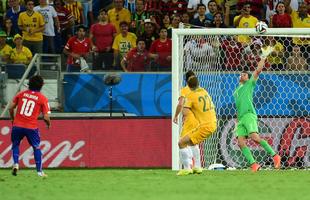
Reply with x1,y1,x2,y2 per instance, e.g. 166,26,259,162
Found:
89,9,116,70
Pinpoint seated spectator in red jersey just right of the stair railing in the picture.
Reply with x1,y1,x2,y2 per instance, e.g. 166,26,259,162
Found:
63,25,91,72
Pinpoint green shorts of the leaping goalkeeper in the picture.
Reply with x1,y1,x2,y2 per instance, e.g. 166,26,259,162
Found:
236,113,258,137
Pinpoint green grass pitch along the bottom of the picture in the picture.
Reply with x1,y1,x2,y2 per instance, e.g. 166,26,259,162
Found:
0,169,310,200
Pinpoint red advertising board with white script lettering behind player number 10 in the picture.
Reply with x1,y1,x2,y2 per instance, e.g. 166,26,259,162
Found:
0,119,171,168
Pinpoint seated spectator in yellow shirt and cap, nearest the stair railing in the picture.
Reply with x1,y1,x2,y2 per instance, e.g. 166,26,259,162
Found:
10,34,32,65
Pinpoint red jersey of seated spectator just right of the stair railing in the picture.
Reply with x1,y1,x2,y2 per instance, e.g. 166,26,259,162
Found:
65,36,91,65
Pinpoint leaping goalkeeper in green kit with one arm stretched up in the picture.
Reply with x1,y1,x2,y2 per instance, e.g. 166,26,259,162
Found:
233,47,281,172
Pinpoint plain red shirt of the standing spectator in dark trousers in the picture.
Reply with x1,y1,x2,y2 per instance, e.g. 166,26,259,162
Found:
90,23,116,52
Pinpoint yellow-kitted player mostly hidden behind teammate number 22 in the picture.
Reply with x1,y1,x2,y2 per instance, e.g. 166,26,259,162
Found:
174,70,202,174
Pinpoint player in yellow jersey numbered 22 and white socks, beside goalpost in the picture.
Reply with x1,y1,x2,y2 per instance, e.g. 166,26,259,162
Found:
174,72,216,176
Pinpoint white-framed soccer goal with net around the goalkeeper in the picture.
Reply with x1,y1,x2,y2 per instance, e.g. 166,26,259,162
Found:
172,28,310,170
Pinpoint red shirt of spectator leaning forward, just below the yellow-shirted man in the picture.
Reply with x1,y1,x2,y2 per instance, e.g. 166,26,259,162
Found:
124,48,149,72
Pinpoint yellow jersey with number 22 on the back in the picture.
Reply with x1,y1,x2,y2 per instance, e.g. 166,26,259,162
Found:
184,87,216,124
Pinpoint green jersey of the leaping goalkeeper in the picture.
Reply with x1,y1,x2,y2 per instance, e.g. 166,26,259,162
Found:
233,76,256,120
